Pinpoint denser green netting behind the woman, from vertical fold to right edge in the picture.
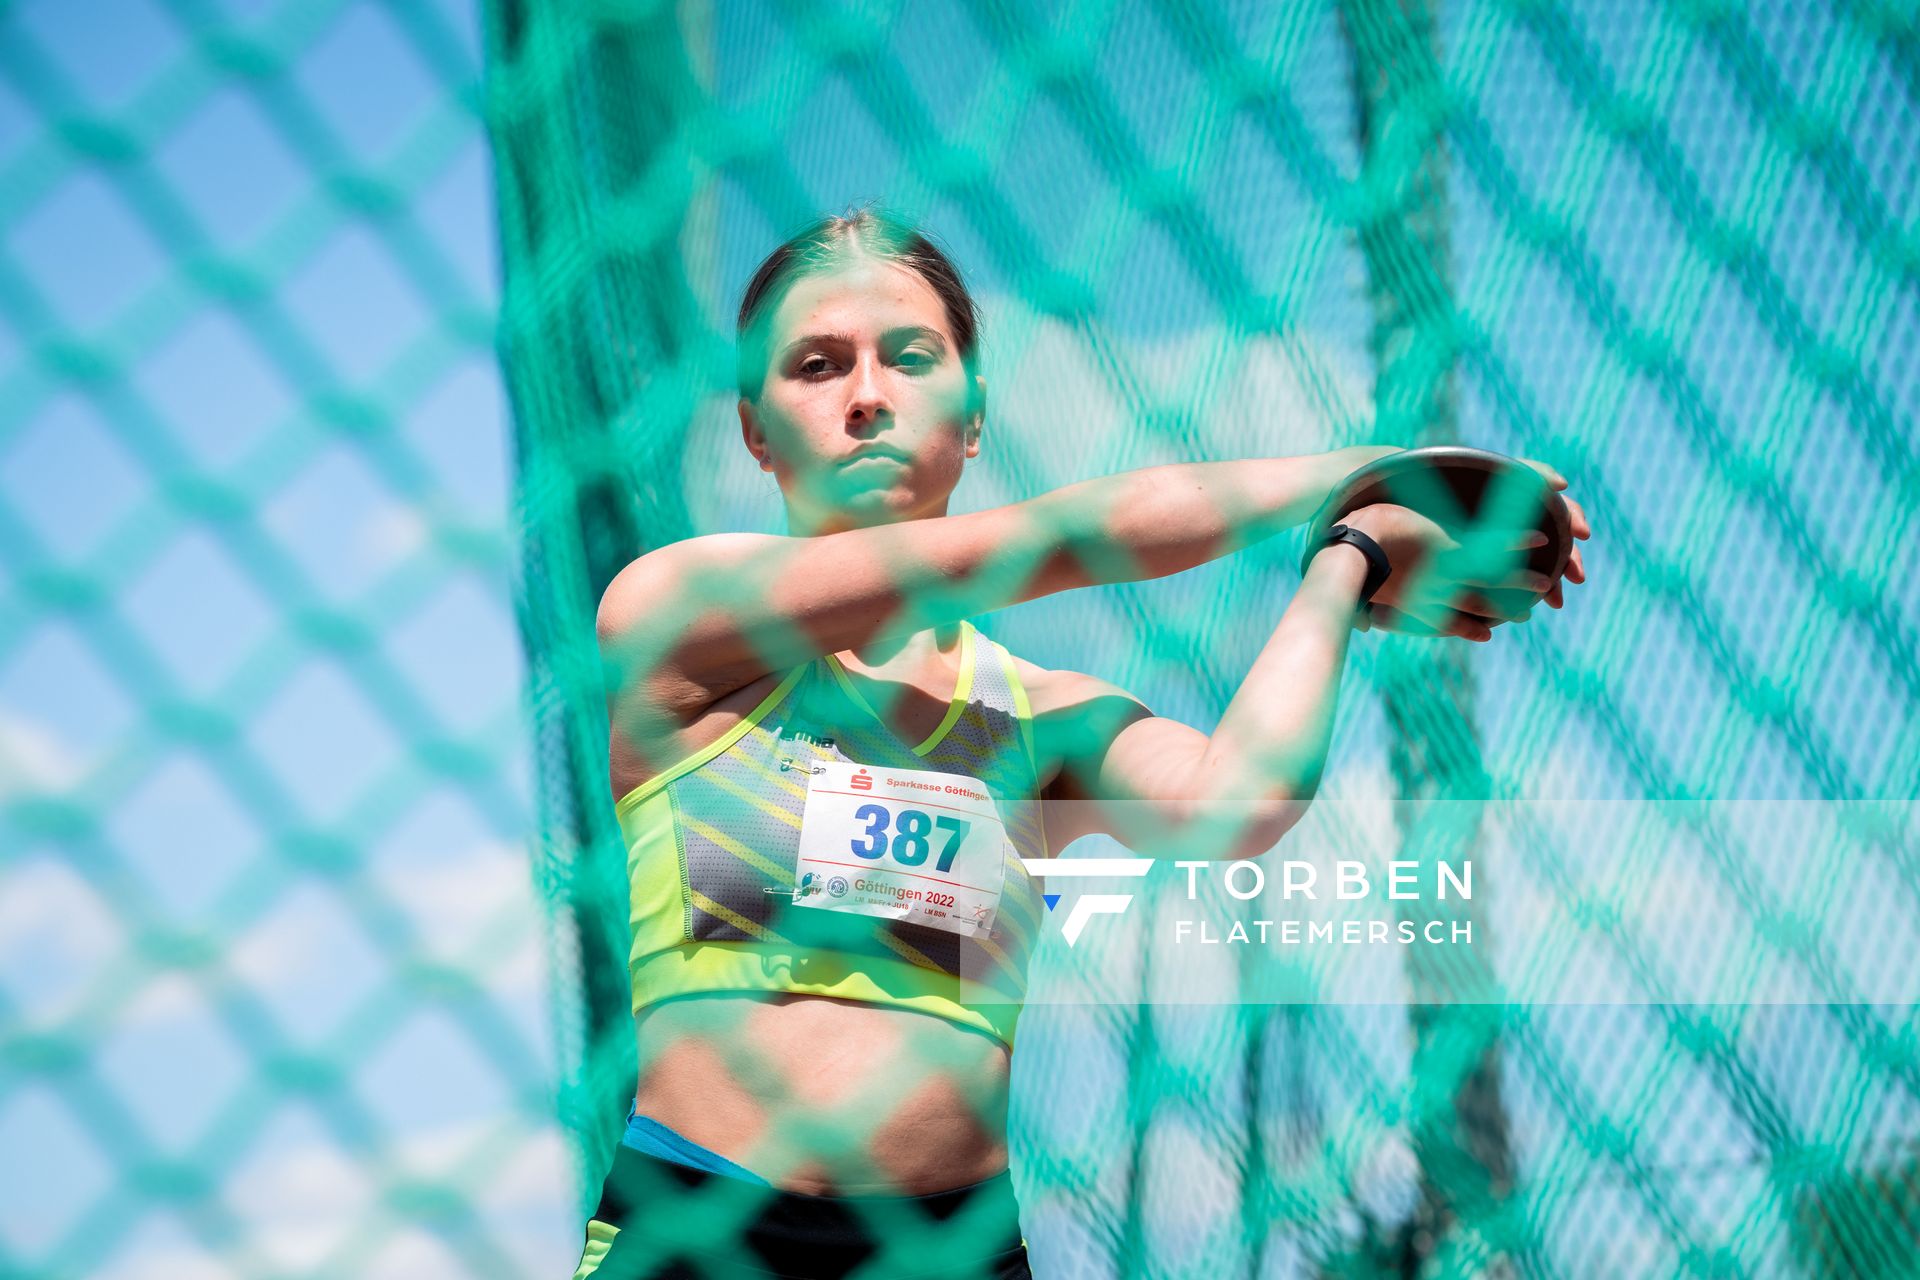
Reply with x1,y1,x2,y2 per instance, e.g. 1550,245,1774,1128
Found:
488,0,1920,1276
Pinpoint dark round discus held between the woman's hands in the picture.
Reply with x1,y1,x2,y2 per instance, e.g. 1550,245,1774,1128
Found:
1300,445,1572,629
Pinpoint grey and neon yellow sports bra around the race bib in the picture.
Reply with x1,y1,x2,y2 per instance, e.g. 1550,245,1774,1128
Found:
614,622,1046,1046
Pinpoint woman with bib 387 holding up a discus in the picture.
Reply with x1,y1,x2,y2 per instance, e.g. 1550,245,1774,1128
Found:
576,209,1588,1280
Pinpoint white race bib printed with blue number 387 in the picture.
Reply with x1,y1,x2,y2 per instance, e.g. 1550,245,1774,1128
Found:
793,760,1006,936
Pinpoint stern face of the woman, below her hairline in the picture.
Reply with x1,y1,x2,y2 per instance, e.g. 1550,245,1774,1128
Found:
739,259,987,532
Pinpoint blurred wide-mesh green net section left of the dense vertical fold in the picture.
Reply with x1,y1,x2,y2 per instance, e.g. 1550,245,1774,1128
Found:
0,0,560,1280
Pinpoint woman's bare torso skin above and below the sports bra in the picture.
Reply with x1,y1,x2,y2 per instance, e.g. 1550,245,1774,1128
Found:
612,629,1010,1196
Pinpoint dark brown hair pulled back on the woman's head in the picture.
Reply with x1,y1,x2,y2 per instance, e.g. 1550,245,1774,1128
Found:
735,205,979,413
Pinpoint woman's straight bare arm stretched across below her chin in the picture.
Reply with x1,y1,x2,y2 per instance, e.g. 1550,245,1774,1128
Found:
599,445,1394,723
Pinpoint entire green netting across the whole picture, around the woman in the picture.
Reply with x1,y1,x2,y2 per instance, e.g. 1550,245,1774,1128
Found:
0,0,1920,1278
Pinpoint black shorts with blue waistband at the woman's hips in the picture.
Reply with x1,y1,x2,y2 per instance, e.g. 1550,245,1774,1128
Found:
574,1144,1033,1280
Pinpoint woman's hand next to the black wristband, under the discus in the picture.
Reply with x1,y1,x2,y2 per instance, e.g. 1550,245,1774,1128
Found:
1340,503,1551,641
